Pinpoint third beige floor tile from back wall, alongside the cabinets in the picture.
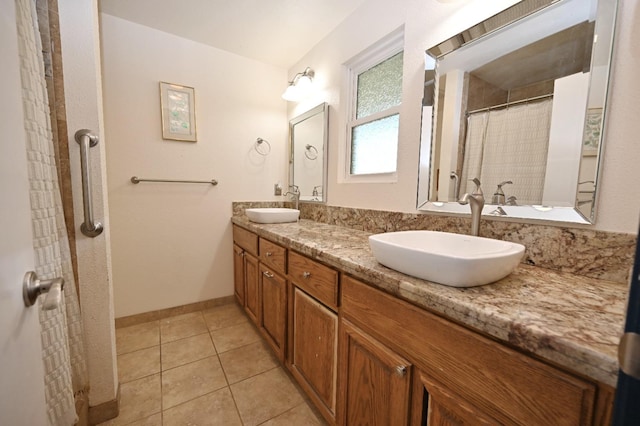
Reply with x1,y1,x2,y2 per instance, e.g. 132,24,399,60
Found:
220,341,278,384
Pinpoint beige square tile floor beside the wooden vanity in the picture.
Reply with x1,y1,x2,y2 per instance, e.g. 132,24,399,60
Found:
101,303,324,426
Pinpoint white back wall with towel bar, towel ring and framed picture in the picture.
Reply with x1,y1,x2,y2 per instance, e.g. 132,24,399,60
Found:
101,14,288,317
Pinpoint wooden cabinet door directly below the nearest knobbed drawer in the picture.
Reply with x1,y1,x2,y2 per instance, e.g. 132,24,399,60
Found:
291,286,338,422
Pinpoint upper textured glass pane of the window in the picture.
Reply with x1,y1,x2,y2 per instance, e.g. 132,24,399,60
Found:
356,52,403,118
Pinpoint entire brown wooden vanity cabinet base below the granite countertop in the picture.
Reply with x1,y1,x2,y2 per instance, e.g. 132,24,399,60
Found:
234,226,614,426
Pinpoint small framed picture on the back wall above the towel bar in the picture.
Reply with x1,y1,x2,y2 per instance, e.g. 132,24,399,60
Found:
160,81,196,142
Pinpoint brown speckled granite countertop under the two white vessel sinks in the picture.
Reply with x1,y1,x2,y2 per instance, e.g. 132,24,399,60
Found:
232,216,628,387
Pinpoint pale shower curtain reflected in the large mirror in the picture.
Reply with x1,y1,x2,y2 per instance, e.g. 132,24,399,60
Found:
460,99,553,204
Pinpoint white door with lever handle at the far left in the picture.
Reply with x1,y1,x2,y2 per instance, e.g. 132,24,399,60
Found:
0,0,47,425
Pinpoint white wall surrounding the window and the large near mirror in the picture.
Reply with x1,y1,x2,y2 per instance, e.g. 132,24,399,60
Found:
289,0,640,233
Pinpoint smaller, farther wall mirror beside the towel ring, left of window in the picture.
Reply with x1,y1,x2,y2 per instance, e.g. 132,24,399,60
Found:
289,103,329,202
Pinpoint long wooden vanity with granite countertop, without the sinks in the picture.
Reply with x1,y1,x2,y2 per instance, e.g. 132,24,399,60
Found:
232,215,627,425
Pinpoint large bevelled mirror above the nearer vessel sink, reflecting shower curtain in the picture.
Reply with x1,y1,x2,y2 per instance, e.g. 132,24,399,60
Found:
418,0,617,223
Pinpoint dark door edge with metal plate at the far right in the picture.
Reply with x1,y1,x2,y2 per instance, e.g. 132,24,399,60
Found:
613,225,640,426
